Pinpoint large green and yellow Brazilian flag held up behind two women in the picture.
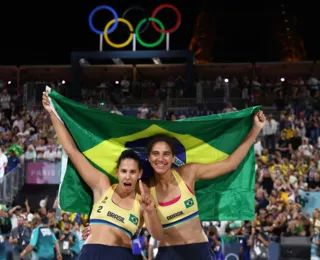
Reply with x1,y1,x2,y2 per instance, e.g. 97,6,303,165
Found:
49,91,259,221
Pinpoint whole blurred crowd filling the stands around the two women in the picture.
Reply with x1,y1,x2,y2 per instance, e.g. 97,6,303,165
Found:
0,64,320,260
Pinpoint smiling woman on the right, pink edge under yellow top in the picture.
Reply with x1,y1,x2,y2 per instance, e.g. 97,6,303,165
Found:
147,111,266,260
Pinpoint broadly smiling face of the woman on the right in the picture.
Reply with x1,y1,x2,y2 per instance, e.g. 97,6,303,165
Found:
149,142,174,174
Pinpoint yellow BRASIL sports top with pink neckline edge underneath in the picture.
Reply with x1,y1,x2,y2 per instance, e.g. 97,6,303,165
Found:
150,169,199,228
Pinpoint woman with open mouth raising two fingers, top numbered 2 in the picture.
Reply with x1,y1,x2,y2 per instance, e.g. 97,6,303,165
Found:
42,92,163,260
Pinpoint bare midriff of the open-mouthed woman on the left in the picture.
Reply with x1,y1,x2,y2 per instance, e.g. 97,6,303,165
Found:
85,225,131,248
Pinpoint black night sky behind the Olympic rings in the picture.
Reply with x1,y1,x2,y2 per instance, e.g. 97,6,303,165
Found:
0,0,320,65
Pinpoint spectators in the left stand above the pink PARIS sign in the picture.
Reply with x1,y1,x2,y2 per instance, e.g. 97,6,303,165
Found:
0,89,61,169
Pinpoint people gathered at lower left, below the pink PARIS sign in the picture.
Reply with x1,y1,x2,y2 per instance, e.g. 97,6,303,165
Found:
0,197,88,260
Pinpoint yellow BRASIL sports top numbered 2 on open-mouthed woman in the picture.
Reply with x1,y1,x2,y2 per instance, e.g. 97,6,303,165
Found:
90,184,140,238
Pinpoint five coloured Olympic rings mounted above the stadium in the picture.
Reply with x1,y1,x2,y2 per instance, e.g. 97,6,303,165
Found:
88,4,181,49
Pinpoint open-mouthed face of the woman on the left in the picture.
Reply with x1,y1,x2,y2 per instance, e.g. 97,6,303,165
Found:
116,159,142,192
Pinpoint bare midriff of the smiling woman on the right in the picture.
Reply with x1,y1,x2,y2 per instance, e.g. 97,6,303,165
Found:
159,217,208,247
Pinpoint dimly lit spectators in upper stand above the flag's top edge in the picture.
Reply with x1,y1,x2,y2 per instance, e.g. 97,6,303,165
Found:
81,76,320,112
